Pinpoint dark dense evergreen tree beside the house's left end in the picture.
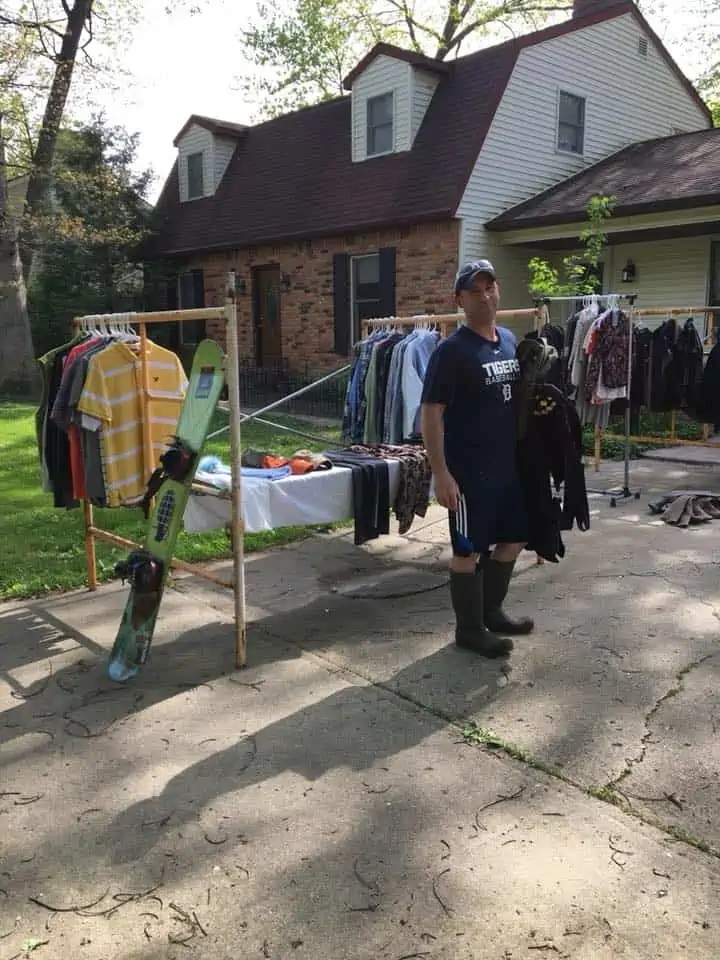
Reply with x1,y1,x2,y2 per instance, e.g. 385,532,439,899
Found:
29,118,152,353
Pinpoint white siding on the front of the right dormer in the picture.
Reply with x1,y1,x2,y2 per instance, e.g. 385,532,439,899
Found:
352,55,412,163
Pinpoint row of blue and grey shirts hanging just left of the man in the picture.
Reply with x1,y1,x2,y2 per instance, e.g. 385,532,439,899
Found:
342,326,439,446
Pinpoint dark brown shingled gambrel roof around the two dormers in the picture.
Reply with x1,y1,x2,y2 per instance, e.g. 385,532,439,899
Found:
146,0,709,257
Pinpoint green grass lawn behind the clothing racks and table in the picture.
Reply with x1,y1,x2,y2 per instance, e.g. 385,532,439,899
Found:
0,402,338,600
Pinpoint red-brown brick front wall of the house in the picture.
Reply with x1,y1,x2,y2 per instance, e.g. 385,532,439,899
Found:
172,220,459,368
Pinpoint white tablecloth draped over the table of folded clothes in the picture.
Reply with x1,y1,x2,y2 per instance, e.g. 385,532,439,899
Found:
183,460,400,533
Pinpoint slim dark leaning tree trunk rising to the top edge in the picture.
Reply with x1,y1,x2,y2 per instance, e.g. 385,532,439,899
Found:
20,0,94,277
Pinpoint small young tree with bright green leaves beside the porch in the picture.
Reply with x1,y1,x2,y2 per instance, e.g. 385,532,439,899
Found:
528,195,615,299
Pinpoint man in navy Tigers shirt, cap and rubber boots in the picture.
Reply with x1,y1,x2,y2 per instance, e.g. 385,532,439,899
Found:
421,260,533,657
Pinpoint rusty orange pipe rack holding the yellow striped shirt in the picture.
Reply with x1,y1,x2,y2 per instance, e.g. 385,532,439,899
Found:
73,288,247,667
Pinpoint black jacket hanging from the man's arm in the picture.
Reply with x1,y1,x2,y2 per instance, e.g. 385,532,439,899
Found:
518,383,590,563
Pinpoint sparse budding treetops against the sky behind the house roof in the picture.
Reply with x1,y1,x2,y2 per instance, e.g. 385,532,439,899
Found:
241,0,720,117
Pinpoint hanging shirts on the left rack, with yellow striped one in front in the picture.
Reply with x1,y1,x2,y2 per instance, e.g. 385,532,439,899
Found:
36,328,188,509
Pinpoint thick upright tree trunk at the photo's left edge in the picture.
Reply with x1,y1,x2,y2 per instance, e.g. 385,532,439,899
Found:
0,115,39,398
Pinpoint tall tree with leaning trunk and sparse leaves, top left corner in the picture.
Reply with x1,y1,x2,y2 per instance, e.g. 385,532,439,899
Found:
0,0,205,392
